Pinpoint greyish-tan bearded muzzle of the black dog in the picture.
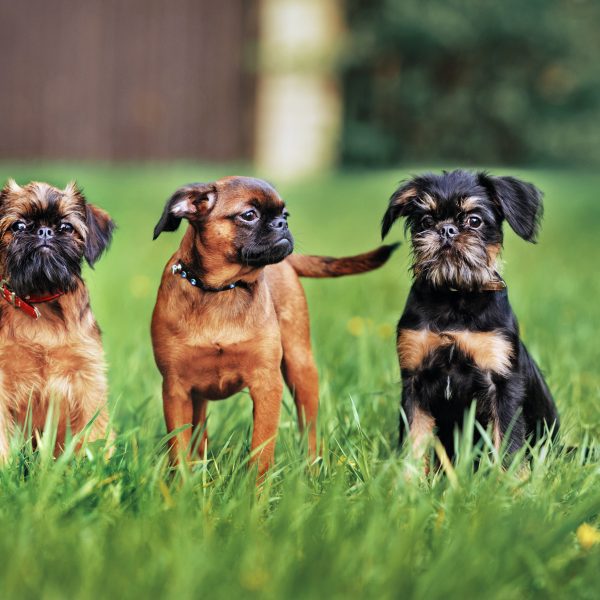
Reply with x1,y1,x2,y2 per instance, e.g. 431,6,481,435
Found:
412,231,497,290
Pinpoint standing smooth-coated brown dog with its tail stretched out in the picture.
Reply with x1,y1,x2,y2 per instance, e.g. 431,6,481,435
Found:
152,177,395,473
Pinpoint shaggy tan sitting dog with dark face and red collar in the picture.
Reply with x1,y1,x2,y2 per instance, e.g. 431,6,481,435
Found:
0,180,114,460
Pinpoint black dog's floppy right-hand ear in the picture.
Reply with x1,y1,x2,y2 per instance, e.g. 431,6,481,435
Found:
478,173,544,242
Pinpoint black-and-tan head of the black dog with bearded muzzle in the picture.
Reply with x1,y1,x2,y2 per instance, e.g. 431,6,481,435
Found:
381,170,542,290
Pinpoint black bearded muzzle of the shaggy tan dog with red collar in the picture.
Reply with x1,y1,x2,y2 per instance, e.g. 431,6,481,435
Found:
5,240,82,296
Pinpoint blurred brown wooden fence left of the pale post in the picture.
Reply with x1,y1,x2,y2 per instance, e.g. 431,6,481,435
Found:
0,0,256,161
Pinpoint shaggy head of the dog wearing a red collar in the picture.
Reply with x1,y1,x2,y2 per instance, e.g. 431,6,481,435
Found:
0,180,114,296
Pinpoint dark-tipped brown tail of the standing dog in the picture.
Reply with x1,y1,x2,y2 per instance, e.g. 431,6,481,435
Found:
287,244,400,277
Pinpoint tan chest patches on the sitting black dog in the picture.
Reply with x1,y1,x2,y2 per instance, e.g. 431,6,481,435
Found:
398,328,514,376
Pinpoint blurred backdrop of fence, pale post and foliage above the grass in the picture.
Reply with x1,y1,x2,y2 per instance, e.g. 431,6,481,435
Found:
0,0,600,178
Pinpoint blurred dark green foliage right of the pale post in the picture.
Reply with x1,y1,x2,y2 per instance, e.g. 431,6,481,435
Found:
340,0,600,165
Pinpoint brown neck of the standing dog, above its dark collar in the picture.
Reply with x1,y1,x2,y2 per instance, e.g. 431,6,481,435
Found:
179,225,263,288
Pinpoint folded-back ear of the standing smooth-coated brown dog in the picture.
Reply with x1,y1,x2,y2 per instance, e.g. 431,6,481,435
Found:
154,183,217,239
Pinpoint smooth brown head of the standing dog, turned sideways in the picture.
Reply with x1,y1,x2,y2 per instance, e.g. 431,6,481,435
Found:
154,177,294,267
